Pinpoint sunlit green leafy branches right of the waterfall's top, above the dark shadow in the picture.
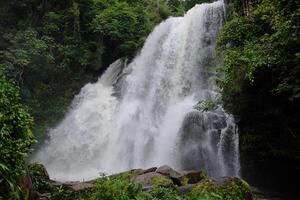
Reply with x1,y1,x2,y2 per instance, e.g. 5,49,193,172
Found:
218,0,299,102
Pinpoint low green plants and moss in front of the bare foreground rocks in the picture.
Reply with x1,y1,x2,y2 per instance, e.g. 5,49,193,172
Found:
29,164,252,200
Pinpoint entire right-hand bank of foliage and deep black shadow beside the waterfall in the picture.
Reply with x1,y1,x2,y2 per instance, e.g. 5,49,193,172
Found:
218,0,300,189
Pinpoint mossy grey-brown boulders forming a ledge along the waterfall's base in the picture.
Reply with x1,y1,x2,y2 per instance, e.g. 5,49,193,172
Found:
29,164,253,200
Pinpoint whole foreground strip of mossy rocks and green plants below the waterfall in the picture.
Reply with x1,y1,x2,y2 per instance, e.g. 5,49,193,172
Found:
28,164,253,200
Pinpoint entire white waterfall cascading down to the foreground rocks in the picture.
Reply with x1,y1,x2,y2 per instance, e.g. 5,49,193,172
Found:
33,1,239,180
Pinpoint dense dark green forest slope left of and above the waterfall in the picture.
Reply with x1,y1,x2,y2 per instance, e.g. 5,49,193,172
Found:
0,0,188,144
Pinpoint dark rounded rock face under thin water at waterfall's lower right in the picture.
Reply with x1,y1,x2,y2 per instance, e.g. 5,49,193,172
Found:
178,110,232,176
